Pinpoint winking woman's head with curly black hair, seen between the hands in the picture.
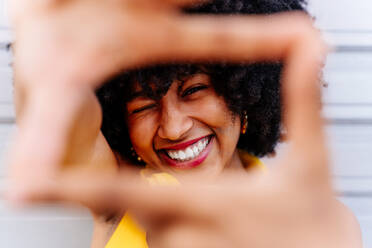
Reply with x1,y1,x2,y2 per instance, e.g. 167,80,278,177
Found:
93,0,305,247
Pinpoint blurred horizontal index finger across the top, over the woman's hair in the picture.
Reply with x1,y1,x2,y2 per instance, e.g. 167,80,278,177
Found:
148,13,310,62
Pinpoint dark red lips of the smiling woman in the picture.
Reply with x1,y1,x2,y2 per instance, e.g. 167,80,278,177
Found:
160,135,214,169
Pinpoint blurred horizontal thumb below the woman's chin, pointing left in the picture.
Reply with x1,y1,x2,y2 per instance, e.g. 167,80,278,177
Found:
21,170,222,219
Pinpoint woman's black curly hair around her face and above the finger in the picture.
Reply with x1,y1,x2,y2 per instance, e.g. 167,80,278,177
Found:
97,0,306,163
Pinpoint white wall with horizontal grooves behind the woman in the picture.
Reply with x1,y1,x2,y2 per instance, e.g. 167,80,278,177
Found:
0,0,372,248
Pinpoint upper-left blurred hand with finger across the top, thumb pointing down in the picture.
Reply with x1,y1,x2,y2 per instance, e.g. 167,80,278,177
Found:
9,0,322,192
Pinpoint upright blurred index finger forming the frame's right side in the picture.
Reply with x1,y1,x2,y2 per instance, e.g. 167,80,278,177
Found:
283,34,328,175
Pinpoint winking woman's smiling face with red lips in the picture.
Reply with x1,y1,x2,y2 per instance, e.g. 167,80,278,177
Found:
127,74,242,177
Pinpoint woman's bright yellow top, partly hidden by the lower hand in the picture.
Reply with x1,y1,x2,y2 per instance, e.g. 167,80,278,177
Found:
105,151,265,248
